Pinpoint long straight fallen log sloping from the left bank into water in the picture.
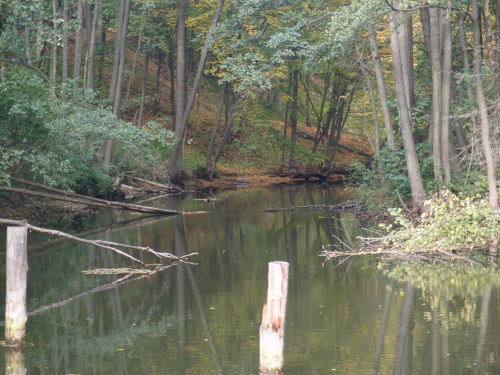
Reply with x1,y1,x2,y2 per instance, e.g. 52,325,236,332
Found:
0,185,182,215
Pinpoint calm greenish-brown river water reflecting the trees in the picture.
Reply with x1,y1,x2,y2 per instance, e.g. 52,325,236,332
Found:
0,186,500,375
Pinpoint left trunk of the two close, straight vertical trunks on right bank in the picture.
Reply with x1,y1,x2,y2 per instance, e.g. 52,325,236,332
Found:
429,8,443,183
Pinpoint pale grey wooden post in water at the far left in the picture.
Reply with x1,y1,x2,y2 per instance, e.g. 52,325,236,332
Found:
5,227,28,346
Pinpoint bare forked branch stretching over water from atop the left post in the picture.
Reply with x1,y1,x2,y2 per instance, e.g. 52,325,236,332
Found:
0,219,198,266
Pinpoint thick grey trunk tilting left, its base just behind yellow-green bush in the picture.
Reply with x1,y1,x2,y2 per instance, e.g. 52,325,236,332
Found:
389,11,425,206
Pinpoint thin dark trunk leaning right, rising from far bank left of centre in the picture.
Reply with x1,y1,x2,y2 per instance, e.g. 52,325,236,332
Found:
169,0,224,183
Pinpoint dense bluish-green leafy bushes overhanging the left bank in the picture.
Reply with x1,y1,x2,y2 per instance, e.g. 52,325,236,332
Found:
0,69,174,196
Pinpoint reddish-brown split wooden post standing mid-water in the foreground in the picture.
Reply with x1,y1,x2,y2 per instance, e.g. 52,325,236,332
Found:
260,262,289,374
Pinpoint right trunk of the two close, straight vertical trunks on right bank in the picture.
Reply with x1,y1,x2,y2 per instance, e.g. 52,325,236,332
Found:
441,6,453,185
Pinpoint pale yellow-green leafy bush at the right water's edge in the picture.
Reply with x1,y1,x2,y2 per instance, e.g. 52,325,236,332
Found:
378,191,500,252
